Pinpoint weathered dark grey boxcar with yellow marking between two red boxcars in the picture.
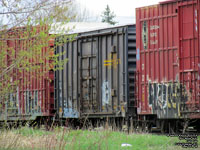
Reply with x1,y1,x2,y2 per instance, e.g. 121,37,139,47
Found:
55,25,136,118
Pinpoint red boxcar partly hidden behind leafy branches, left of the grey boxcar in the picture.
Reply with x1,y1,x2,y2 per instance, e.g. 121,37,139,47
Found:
0,26,54,121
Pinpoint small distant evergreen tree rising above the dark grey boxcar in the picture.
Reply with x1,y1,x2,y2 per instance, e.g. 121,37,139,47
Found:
101,5,117,25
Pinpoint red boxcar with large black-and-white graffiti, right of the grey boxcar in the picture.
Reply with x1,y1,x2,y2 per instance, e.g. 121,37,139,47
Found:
136,0,200,119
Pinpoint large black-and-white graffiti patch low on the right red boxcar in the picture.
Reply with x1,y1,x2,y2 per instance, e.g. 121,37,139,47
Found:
148,83,188,118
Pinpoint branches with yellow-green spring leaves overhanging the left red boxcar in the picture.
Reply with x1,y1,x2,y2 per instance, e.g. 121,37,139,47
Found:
0,0,75,112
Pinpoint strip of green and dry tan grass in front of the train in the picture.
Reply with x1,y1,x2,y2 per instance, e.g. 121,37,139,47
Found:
0,127,200,150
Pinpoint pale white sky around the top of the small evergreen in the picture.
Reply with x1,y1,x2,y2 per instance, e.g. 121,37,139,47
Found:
76,0,165,23
